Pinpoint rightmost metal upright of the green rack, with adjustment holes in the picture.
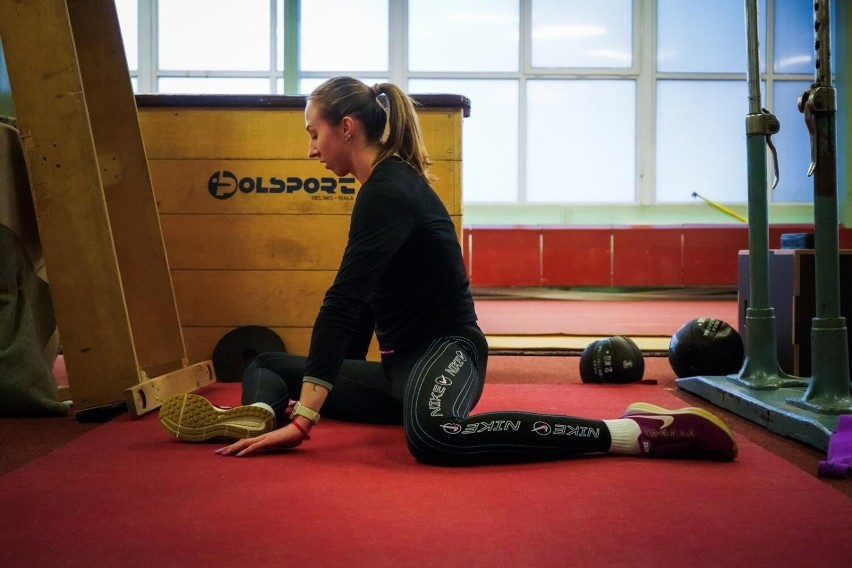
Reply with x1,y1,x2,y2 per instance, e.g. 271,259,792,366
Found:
788,0,852,408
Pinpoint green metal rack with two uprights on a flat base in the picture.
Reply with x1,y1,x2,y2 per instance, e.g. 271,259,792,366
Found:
676,0,852,450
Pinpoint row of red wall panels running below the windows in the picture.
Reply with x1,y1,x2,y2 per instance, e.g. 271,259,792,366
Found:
462,225,852,287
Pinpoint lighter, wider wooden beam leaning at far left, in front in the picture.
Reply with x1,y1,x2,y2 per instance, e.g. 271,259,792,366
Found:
0,0,139,410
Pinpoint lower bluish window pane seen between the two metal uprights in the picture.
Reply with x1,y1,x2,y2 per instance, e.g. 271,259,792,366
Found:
770,81,814,203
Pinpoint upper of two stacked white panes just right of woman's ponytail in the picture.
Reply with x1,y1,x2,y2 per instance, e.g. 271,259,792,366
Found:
408,0,520,71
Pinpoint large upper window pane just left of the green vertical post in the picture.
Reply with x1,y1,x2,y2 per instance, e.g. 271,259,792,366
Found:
158,0,270,71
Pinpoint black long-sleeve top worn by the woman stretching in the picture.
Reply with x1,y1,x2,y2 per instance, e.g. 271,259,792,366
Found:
305,158,476,388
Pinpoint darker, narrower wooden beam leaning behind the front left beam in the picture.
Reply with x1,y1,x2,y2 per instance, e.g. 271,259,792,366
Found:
68,0,186,375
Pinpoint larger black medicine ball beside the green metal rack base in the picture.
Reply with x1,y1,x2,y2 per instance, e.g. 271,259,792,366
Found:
669,318,745,378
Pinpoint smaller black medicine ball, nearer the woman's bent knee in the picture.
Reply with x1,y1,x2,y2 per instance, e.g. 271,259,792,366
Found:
580,335,645,384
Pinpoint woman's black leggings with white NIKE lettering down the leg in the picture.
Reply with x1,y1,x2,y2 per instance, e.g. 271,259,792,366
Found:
242,326,610,465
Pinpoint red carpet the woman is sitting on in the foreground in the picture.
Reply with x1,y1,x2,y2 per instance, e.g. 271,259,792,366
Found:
0,383,852,567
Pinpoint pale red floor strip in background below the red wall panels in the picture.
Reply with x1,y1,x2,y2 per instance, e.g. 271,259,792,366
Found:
476,298,737,336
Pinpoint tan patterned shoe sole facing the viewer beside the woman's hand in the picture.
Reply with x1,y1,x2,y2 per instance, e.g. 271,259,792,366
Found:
160,394,275,442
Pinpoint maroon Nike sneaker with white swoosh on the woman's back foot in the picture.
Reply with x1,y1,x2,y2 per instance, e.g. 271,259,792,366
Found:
622,402,737,461
